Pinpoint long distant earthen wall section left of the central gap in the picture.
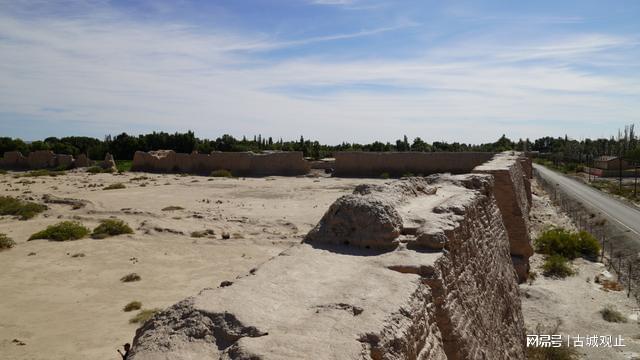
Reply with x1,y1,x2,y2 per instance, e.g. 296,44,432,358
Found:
131,150,309,176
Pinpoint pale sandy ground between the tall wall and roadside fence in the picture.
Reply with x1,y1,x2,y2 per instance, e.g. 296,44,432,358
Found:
520,181,640,360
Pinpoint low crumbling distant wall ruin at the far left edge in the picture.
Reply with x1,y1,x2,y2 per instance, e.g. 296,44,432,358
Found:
0,150,88,170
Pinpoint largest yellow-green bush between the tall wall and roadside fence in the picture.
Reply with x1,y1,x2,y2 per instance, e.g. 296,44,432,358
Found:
534,228,600,259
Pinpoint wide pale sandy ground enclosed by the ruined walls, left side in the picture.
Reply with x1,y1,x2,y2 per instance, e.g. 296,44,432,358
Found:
0,172,382,360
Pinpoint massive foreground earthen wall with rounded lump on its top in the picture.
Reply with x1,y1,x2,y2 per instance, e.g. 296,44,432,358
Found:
131,174,525,360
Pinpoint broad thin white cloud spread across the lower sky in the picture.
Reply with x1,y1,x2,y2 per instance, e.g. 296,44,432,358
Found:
0,3,640,142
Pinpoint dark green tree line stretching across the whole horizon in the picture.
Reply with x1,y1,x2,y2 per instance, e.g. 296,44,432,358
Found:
0,125,640,162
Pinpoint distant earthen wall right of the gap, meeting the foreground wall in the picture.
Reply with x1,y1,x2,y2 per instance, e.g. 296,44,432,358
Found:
334,151,493,177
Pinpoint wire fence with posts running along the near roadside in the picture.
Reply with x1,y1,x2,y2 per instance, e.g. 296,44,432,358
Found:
534,169,640,301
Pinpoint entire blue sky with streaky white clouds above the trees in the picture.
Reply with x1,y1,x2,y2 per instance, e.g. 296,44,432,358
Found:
0,0,640,144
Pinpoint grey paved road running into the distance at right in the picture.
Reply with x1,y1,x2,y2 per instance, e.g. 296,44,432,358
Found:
534,164,640,241
